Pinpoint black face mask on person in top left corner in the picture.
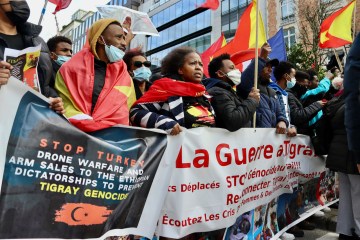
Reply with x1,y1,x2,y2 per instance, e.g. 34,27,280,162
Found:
5,1,30,26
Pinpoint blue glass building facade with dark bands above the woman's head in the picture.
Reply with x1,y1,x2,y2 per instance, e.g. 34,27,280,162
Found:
147,0,212,68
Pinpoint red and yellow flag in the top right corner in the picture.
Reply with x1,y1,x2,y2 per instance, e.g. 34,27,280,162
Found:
319,1,355,48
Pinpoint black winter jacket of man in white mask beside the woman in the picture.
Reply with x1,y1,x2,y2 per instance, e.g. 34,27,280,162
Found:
203,78,259,131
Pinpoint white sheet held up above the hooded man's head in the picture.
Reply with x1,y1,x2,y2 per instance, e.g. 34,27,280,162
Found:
97,5,159,36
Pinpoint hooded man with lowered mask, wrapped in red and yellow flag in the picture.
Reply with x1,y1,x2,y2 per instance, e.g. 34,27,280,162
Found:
55,19,135,132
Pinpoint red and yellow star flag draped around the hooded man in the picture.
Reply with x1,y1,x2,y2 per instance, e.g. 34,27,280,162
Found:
55,48,136,132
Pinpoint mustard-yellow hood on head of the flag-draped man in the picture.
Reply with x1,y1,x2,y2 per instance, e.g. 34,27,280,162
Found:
88,18,121,58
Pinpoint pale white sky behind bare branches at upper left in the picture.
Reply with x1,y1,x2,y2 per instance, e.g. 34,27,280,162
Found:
27,0,109,41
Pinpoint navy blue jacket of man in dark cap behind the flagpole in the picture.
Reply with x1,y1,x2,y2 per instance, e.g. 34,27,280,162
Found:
236,58,289,128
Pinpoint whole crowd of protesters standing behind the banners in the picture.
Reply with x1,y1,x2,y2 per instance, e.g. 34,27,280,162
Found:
0,0,360,239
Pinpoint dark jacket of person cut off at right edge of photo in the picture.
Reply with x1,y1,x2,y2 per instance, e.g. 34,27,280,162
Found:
344,34,360,164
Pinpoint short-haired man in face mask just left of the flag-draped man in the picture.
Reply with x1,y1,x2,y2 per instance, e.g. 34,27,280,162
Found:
47,36,72,87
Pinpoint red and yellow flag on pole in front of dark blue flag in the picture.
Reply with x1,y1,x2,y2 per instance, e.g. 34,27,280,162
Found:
214,1,266,64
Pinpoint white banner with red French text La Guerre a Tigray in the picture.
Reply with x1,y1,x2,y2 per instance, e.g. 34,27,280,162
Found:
158,128,325,238
